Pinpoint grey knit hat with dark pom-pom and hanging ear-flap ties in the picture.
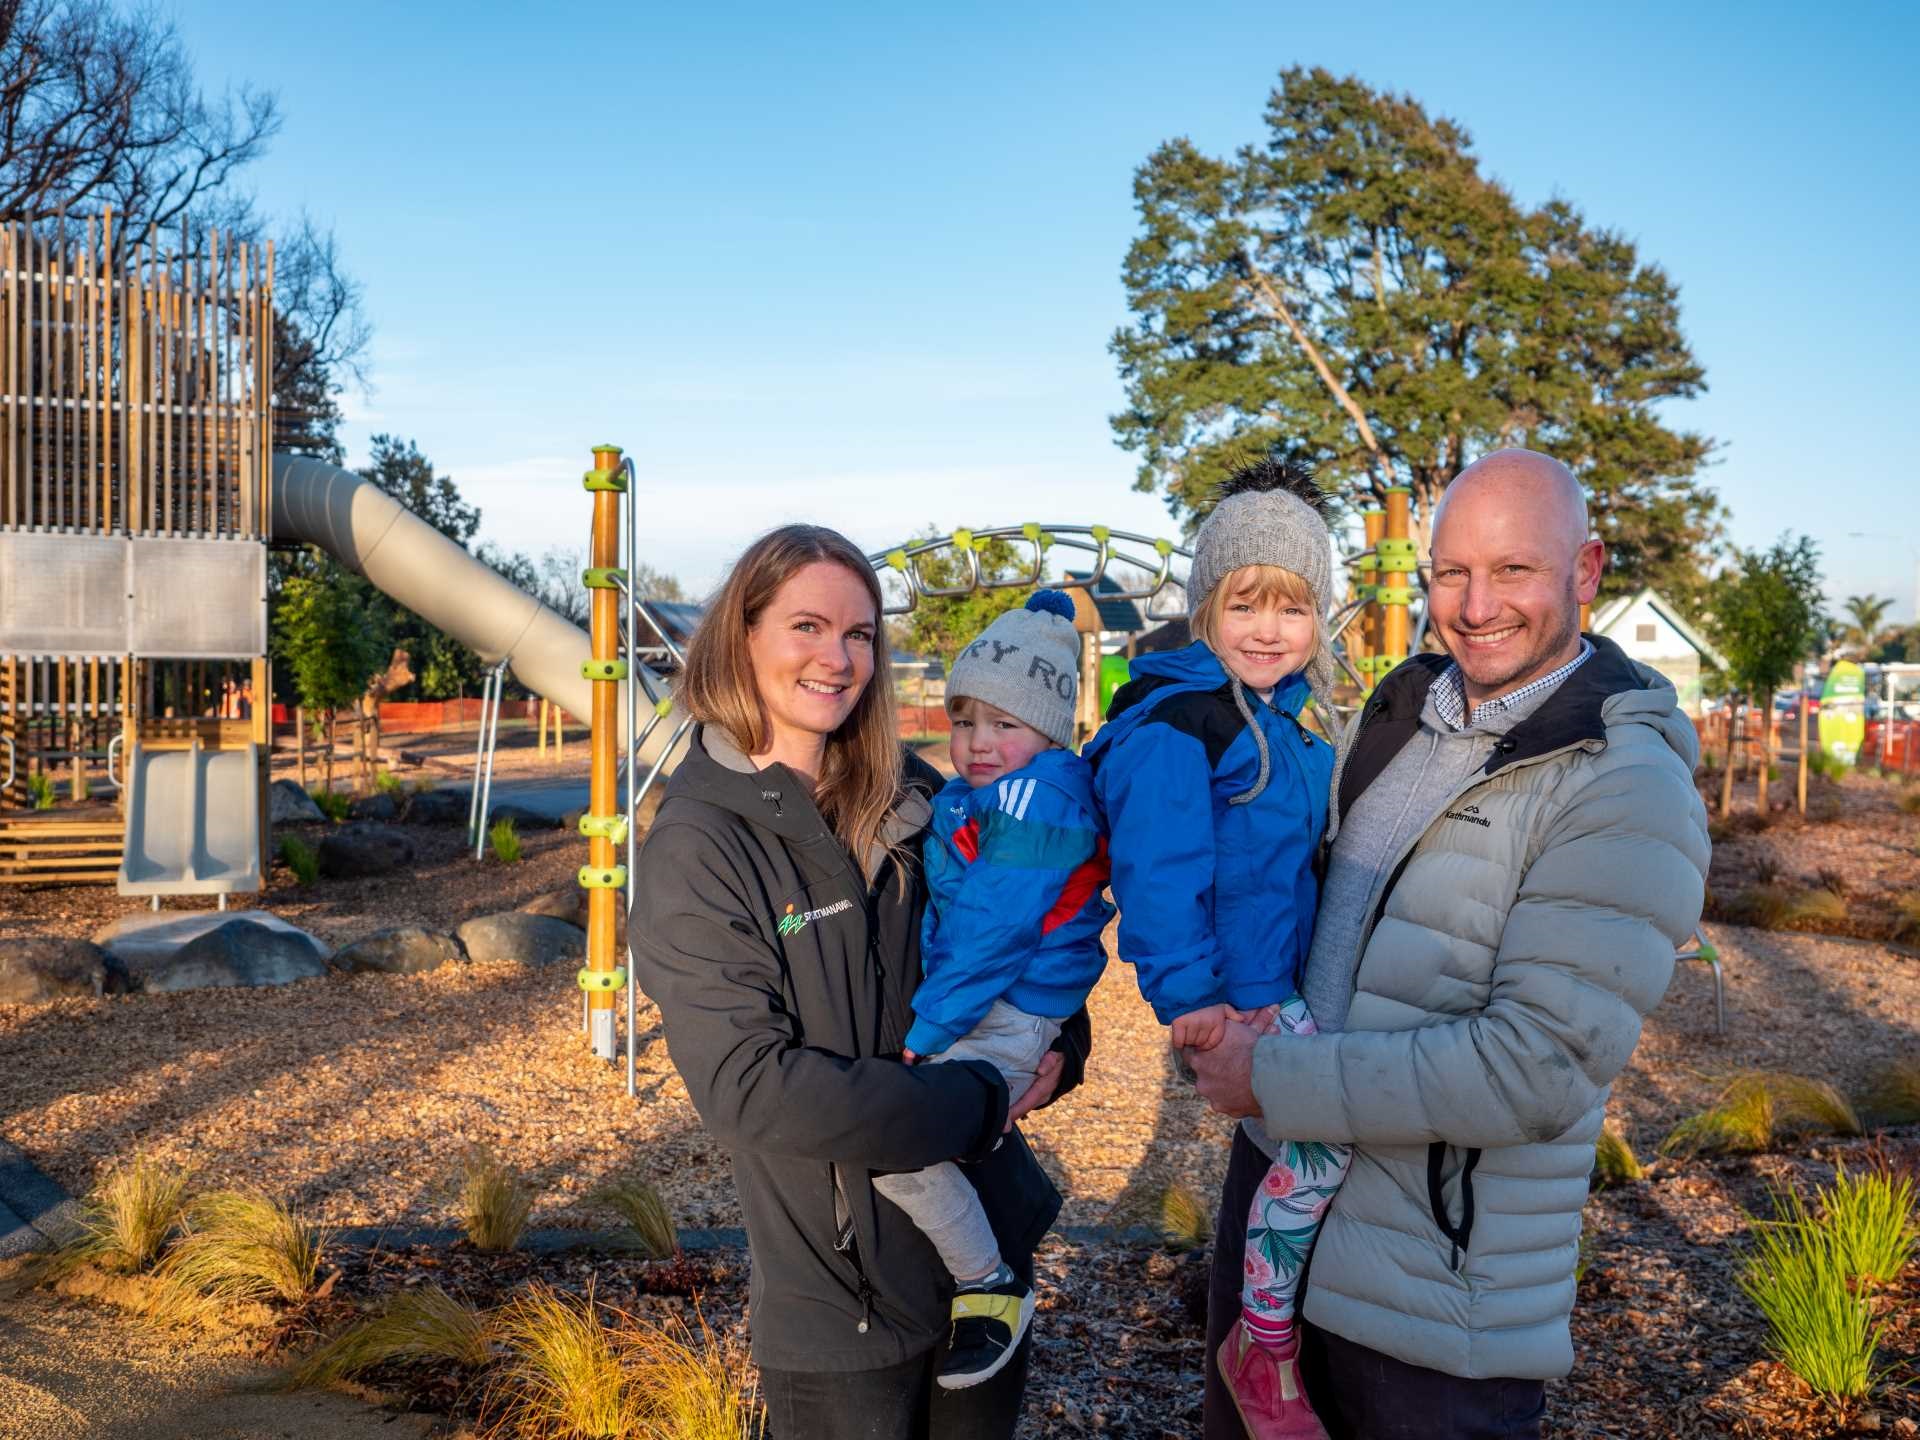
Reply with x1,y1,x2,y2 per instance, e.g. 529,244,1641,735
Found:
1187,461,1334,804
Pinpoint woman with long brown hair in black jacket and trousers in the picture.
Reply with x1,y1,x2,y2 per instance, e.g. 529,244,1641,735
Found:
630,526,1087,1440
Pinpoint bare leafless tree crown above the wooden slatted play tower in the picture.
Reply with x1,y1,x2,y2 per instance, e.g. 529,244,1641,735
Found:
0,0,280,244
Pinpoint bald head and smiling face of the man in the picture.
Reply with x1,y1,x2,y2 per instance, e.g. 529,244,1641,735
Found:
1428,449,1607,705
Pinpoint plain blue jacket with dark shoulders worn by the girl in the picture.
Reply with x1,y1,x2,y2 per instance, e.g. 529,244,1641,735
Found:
1087,641,1332,1025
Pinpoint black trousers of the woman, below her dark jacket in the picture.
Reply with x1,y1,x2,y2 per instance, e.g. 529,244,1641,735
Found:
760,1334,1033,1440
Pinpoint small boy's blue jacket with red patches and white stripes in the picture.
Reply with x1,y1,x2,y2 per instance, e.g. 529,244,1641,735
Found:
906,751,1114,1054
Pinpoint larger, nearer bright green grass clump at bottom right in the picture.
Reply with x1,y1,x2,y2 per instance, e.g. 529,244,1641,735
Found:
1738,1196,1882,1398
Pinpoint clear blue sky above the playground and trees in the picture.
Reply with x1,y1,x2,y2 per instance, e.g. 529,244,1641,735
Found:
173,0,1920,618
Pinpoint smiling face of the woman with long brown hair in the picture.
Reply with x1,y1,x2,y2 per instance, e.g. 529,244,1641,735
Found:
747,561,879,753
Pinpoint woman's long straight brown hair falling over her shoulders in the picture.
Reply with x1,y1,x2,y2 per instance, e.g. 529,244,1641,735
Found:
678,524,900,866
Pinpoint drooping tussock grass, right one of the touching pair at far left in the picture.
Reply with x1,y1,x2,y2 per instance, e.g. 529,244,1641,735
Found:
157,1190,326,1306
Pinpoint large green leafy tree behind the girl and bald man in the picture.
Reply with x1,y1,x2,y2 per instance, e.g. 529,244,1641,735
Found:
1112,69,1718,603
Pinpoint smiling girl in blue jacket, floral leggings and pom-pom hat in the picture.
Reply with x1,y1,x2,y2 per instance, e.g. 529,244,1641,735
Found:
1087,463,1348,1440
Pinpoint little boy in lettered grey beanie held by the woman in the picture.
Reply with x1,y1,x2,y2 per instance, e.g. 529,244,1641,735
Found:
874,589,1114,1390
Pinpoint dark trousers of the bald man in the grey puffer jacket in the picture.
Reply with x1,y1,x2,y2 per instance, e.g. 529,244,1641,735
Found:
1204,1131,1546,1440
